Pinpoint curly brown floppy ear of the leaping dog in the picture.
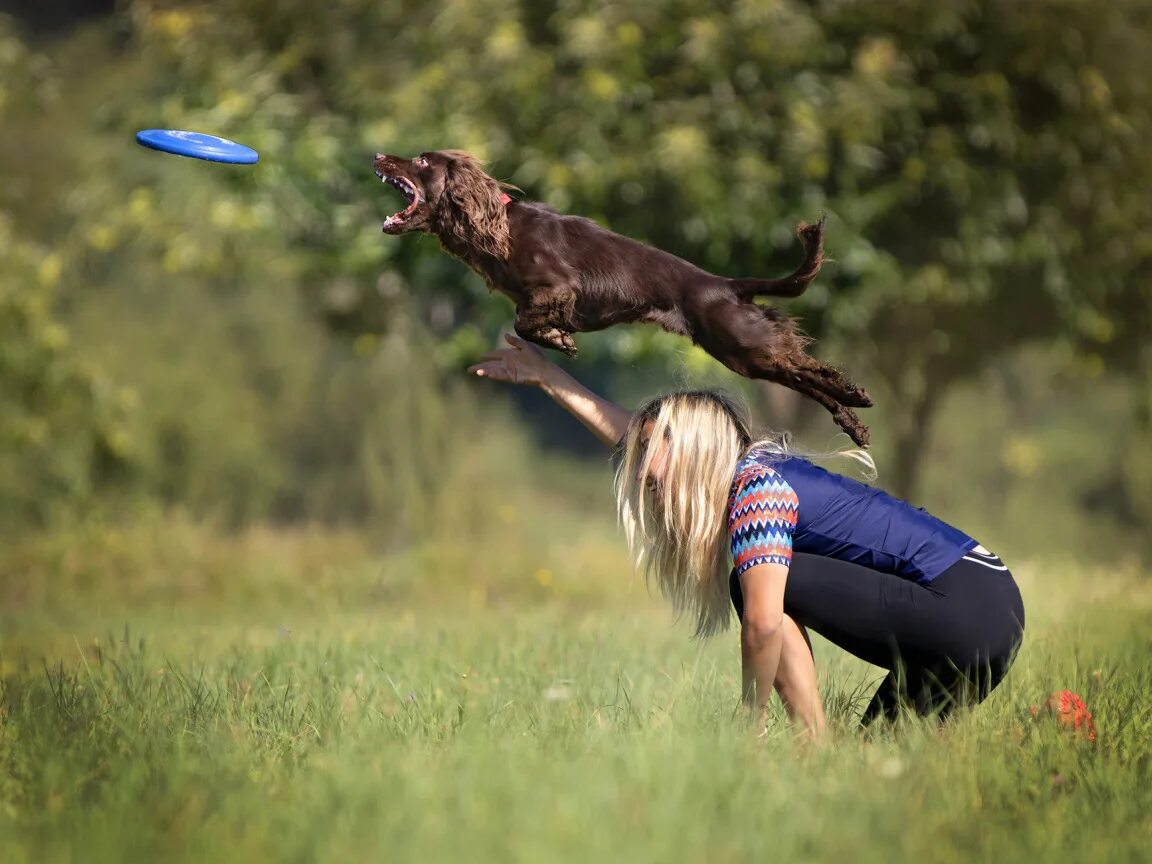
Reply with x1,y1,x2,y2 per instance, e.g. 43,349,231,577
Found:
444,150,509,258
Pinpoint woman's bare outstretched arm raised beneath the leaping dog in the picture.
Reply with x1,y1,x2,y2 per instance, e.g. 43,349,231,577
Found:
468,334,632,447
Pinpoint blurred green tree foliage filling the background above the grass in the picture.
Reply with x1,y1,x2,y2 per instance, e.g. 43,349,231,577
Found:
0,0,1152,551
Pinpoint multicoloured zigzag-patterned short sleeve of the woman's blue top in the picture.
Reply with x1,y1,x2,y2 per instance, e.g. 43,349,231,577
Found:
728,463,799,575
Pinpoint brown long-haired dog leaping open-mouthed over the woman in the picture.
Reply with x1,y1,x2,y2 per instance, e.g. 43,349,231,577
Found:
373,150,872,446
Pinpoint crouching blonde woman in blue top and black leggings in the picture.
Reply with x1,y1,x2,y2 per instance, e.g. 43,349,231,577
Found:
469,336,1024,734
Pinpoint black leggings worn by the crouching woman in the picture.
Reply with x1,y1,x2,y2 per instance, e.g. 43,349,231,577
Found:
730,552,1024,725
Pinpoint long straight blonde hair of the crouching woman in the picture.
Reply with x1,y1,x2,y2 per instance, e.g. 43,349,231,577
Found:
615,391,876,636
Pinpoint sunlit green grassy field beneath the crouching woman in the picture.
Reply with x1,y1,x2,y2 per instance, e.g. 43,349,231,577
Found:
0,511,1152,864
